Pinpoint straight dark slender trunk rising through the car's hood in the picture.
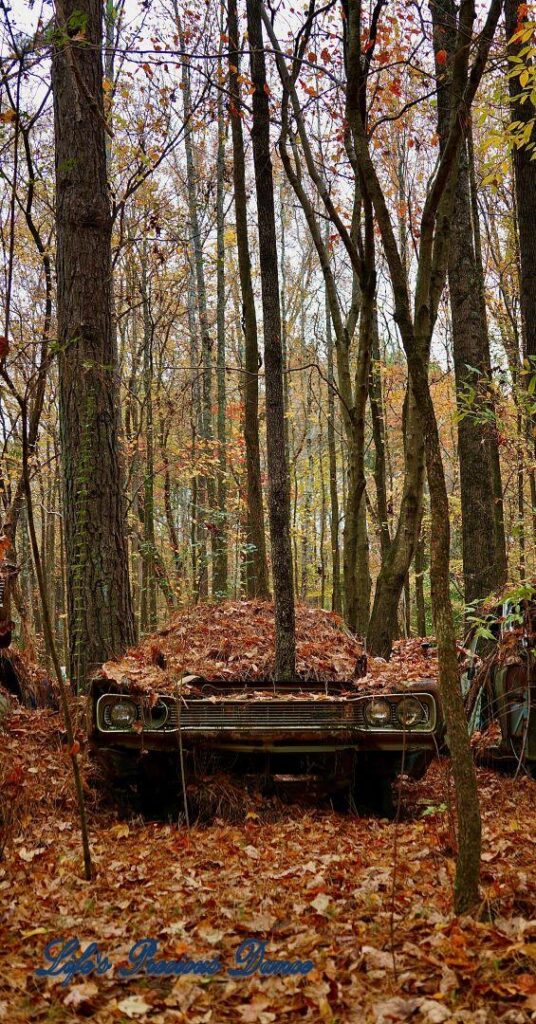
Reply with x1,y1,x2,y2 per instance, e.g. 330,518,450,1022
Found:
247,0,296,679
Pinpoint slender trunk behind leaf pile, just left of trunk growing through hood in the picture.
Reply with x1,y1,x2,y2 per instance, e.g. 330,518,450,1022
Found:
228,0,270,598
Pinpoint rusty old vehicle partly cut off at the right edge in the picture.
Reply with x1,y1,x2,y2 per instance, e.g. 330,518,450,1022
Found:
462,588,536,775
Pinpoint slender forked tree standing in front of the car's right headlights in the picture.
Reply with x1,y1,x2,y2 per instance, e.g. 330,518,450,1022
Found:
347,0,501,913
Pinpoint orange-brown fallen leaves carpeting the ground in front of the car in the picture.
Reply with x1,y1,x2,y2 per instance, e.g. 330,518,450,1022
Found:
0,708,536,1024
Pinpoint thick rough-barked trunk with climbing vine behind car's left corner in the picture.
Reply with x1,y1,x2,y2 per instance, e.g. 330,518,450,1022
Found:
52,0,134,686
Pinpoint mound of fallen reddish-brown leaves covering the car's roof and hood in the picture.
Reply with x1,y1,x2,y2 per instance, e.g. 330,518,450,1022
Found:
101,601,438,693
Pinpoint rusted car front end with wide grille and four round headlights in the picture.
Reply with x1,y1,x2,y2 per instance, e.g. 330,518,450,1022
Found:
89,676,443,816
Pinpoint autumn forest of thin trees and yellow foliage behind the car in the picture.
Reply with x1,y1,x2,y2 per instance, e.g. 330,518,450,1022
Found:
0,0,536,682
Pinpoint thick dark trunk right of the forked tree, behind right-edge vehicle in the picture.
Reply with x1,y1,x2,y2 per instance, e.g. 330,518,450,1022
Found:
430,0,506,604
